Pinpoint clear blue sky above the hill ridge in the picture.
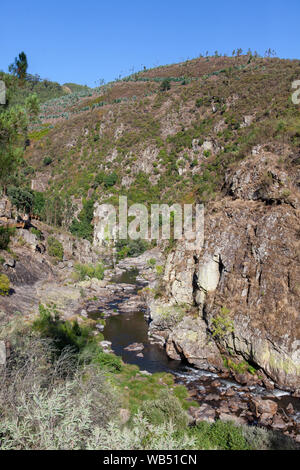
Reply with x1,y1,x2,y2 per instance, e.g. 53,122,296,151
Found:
0,0,300,86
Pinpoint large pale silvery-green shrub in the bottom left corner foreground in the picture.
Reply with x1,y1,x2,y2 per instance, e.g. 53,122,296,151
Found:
0,323,119,450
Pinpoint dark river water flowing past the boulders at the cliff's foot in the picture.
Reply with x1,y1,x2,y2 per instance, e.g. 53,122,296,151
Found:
93,270,300,421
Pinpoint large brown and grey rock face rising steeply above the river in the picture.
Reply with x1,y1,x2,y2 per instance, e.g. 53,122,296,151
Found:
149,154,300,390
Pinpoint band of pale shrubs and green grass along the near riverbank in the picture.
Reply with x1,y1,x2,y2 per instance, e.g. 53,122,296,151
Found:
0,307,297,450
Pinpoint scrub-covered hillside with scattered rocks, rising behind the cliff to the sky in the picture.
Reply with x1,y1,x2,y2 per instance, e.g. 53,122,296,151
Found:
20,56,300,224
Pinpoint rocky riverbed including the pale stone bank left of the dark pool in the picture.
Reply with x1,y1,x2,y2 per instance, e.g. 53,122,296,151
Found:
0,233,300,441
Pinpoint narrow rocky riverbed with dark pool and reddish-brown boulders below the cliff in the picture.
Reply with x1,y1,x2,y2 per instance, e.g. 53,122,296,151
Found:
84,255,300,442
